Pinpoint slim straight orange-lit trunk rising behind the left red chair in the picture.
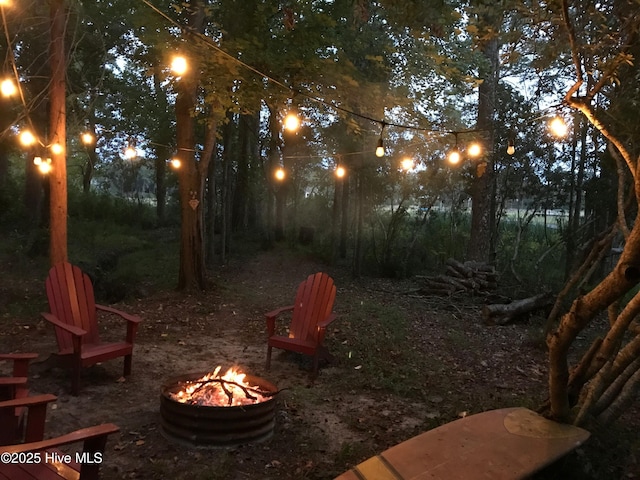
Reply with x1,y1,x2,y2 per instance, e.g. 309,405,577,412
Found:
48,0,67,265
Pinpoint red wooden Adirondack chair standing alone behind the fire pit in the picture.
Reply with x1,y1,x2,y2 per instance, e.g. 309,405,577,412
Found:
265,272,336,378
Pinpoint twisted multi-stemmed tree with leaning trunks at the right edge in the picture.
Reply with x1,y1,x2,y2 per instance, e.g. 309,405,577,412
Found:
547,0,640,424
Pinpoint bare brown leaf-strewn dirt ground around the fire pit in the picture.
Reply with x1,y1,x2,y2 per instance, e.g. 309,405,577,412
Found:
0,251,640,480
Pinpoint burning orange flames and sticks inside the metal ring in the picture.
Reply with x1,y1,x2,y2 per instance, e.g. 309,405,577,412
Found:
170,365,273,407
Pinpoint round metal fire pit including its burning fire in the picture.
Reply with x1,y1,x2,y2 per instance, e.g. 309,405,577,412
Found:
160,367,278,447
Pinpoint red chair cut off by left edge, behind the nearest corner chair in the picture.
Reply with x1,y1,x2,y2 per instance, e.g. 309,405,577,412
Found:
0,353,38,445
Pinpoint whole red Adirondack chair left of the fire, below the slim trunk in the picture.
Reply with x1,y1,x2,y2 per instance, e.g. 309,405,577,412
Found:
42,262,141,395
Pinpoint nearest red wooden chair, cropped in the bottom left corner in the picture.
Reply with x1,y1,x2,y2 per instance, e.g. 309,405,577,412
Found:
0,395,119,480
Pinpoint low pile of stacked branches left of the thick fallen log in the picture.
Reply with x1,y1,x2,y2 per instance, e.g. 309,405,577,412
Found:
417,258,498,295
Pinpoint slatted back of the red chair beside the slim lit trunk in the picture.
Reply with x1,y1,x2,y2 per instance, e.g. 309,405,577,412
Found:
45,262,100,351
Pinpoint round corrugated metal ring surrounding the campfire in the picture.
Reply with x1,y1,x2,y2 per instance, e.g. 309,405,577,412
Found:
160,372,278,448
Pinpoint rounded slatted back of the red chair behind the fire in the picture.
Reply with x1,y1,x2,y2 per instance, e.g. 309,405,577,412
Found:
289,272,336,341
